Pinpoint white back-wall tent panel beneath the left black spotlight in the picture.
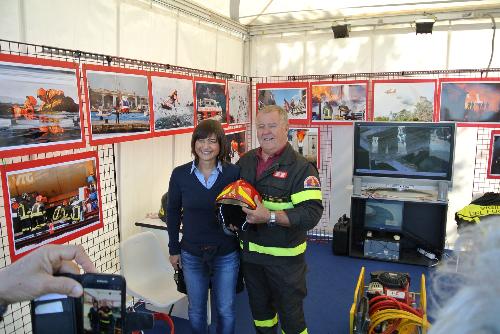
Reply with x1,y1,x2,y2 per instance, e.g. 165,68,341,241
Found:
304,33,372,74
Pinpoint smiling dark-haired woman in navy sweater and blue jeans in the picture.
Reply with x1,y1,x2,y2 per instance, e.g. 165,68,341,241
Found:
167,119,239,334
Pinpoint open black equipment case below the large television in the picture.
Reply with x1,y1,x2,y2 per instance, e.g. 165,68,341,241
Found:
349,196,448,266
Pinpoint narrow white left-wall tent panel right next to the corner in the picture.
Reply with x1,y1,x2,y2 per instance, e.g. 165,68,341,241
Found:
216,31,243,75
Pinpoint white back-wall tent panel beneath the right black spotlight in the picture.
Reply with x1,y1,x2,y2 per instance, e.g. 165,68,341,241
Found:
373,31,447,72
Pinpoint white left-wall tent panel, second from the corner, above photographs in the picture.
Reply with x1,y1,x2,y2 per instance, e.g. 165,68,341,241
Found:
177,19,217,71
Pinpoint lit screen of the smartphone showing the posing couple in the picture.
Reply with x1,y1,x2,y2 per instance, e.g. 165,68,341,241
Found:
83,288,122,334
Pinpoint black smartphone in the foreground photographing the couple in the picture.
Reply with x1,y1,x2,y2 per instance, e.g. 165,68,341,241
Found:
81,274,126,334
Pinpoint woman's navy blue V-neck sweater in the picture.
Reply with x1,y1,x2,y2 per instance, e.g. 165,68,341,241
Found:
167,162,239,256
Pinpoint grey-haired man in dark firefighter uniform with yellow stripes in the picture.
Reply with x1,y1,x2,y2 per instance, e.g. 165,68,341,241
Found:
238,106,323,334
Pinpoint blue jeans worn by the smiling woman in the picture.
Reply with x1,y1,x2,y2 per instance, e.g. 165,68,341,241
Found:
181,250,240,334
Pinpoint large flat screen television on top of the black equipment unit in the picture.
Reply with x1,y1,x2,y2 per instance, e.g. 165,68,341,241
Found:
354,122,455,181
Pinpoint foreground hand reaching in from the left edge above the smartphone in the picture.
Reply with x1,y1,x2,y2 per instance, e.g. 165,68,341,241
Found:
0,245,96,304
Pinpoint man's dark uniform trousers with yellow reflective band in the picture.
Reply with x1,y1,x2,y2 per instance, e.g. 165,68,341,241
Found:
243,261,307,334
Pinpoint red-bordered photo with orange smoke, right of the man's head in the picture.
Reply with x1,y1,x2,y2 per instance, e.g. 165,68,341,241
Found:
309,81,368,124
